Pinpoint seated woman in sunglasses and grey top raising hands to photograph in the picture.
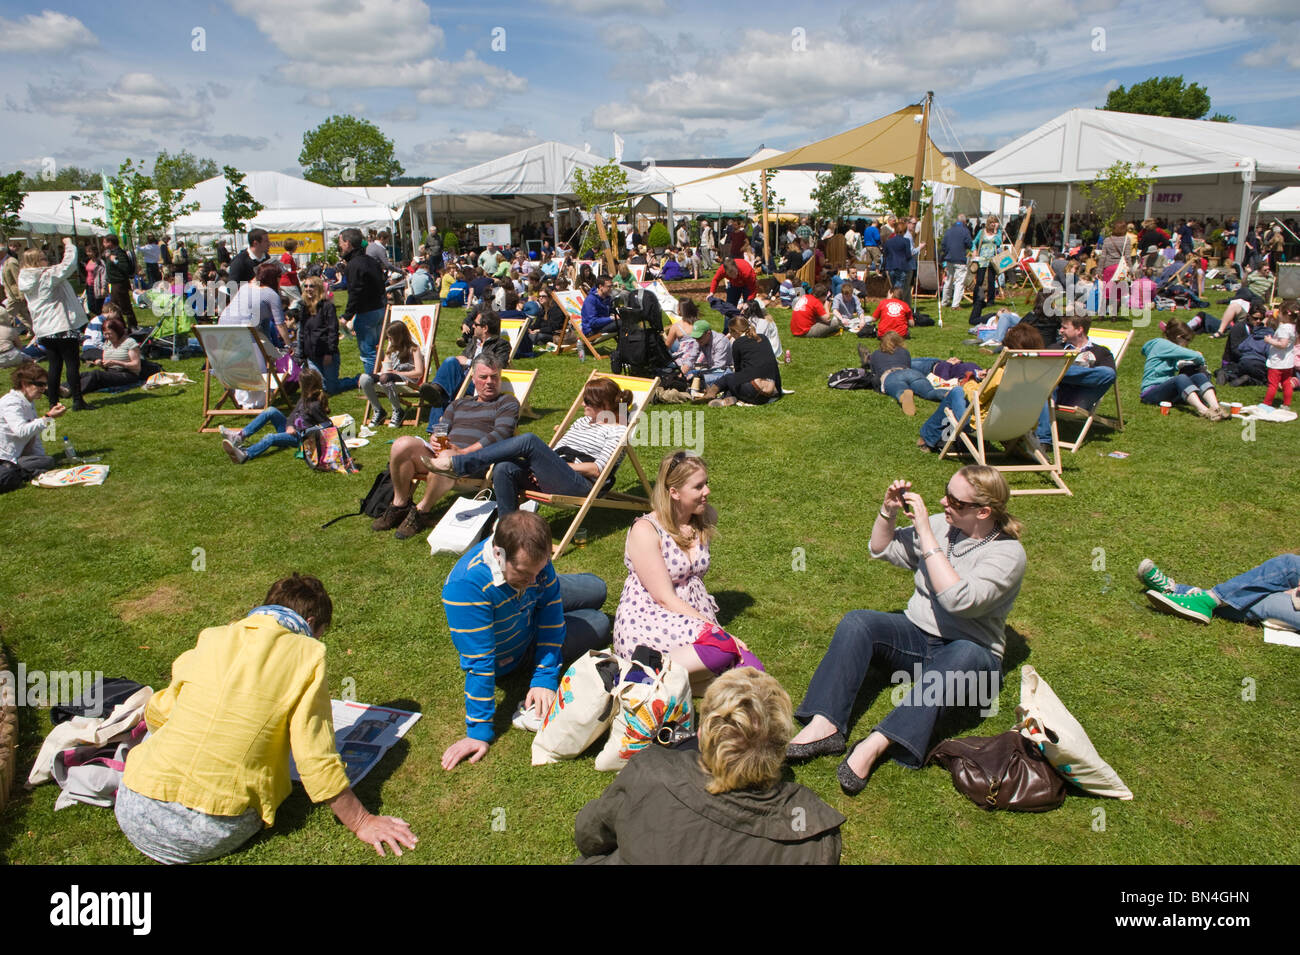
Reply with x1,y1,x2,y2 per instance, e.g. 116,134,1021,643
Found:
787,465,1026,795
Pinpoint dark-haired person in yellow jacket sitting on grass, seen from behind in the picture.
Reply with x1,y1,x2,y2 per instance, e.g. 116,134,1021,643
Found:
114,573,419,864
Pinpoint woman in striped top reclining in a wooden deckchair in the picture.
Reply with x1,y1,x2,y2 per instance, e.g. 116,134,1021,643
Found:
430,378,632,517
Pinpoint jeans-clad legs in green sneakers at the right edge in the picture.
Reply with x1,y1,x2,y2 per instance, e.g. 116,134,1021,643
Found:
1138,554,1300,630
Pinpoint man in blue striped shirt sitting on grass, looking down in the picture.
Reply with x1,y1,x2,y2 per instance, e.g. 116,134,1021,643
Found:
442,511,610,769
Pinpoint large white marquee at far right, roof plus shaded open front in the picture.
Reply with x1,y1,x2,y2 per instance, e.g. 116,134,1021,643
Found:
969,109,1300,226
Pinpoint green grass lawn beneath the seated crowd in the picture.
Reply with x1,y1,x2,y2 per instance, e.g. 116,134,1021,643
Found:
0,294,1300,864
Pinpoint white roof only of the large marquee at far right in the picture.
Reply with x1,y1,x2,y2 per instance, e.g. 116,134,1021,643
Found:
969,109,1300,186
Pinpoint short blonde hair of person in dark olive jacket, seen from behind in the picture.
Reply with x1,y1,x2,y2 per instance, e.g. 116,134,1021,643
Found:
699,667,794,795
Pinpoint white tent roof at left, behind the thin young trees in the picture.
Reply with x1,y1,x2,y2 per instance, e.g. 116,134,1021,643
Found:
176,170,393,234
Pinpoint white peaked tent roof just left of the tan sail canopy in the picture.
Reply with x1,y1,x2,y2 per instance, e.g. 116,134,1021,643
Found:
424,142,672,214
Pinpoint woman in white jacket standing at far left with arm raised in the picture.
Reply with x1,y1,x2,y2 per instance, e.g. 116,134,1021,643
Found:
18,238,90,411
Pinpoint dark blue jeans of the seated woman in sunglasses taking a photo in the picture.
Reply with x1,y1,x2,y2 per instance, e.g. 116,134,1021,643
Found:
794,611,1002,769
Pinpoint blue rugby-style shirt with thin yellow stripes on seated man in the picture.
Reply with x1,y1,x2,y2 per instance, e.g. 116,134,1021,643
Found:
442,538,566,743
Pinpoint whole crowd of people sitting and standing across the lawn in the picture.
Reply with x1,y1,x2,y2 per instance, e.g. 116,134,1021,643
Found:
0,210,1300,863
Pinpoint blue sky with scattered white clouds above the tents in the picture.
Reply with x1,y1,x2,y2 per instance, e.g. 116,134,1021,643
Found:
0,0,1300,175
